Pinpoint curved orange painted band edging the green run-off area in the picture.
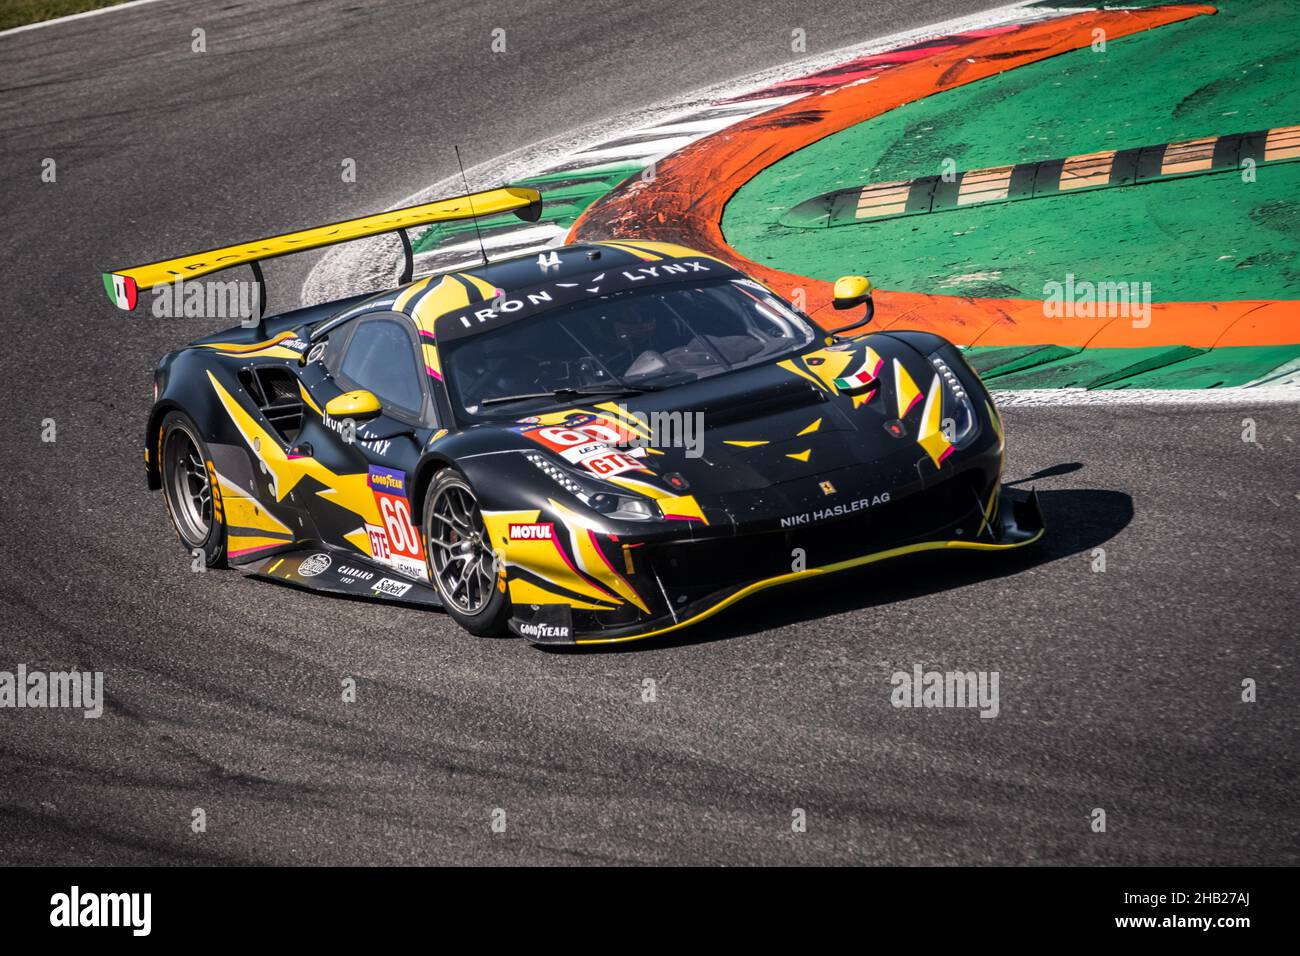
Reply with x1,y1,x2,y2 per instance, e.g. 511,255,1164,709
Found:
568,4,1300,347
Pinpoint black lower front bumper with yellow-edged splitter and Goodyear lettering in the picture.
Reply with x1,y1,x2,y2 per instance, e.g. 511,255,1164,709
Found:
511,483,1044,645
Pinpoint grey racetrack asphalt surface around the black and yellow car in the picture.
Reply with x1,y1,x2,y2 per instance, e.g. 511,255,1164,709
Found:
0,0,1300,865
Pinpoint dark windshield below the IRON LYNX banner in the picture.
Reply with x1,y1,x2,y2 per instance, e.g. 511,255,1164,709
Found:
442,280,816,418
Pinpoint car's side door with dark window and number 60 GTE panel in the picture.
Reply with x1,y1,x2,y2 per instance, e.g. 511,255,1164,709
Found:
298,312,437,580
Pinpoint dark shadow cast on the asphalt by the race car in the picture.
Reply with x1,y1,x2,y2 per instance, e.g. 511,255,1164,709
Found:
543,486,1134,653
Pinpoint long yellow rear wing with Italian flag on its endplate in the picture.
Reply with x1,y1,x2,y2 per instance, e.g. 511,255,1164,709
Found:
104,186,542,311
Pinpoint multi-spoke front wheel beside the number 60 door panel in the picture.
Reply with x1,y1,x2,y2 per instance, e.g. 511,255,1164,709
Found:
423,468,510,635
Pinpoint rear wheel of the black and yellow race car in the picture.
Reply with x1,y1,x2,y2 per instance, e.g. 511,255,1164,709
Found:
159,411,226,567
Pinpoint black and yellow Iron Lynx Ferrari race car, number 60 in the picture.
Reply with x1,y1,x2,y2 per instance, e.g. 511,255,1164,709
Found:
104,187,1043,645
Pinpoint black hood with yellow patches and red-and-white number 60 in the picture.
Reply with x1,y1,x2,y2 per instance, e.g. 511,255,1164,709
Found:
515,334,950,496
